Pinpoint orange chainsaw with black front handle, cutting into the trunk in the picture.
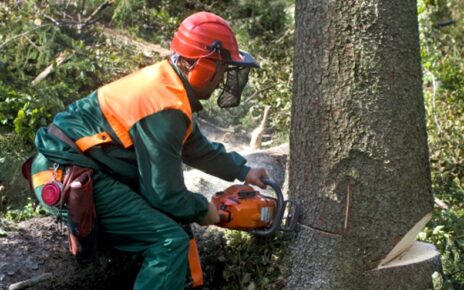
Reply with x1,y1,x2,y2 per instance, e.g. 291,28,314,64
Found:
211,179,299,236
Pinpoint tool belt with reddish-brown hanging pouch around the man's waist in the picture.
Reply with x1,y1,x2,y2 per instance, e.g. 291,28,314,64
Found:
22,124,98,256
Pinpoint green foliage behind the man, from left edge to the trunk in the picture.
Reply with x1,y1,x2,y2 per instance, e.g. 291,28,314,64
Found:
0,0,293,142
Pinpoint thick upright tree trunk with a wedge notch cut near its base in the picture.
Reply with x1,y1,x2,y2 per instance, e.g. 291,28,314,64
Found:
288,0,440,289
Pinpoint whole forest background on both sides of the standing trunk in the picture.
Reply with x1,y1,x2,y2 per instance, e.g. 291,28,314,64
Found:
0,0,464,289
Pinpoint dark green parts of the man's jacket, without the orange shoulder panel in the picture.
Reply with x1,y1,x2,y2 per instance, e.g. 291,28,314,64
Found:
35,61,249,223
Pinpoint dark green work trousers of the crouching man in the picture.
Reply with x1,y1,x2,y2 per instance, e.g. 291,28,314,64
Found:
32,154,189,290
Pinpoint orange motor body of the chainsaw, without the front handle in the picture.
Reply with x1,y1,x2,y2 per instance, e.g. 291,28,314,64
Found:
211,185,277,231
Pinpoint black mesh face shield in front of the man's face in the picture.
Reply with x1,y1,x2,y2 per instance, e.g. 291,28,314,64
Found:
217,66,250,108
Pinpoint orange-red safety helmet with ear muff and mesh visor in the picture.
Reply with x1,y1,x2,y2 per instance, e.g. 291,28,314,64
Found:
171,12,259,108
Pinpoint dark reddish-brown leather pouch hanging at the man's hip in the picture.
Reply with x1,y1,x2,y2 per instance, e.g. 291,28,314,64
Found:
58,165,98,256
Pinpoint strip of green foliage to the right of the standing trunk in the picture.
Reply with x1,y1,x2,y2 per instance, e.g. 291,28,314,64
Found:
418,0,464,289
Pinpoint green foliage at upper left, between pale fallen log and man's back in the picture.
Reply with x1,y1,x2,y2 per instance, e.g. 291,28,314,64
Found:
0,1,151,143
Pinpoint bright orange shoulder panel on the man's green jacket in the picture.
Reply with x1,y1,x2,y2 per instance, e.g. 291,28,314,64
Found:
98,60,192,148
